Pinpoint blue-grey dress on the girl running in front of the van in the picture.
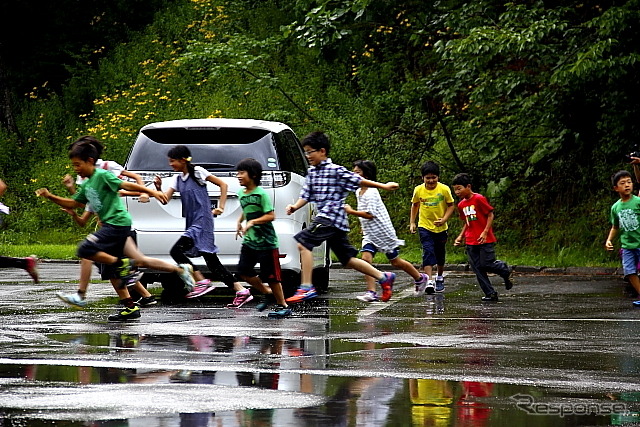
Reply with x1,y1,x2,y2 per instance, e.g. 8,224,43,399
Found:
172,166,218,255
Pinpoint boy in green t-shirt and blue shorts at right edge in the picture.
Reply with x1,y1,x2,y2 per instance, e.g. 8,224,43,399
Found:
605,170,640,307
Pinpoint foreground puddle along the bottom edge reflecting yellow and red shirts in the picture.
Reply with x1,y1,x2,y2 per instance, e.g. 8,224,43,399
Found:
0,364,640,427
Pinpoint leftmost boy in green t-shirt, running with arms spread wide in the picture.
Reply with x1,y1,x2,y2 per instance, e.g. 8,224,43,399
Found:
36,142,194,321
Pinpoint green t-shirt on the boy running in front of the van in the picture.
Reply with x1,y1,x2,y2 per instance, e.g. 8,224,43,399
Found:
238,187,278,251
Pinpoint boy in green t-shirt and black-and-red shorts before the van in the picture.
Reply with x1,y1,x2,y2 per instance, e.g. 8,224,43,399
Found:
236,158,291,317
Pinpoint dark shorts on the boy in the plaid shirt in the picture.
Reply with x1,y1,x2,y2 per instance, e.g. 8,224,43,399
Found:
293,218,358,265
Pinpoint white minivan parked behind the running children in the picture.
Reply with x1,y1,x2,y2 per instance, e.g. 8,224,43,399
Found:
125,119,331,295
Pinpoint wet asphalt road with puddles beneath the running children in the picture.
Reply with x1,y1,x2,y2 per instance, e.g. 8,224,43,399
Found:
0,263,640,426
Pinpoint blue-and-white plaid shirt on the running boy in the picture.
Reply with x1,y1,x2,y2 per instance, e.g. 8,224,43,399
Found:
300,159,362,231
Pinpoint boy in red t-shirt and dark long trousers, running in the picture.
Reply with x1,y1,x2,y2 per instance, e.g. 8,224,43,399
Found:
453,173,513,301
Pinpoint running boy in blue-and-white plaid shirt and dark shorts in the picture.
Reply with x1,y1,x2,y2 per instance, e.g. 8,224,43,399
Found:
286,132,398,303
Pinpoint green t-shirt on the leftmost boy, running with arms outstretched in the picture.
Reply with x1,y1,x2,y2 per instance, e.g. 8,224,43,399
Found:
72,168,131,227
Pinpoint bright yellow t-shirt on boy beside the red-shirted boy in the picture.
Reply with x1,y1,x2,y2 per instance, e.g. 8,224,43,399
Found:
411,182,453,233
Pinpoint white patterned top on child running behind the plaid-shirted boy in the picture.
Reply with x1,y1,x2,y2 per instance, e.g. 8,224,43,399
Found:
356,188,402,253
